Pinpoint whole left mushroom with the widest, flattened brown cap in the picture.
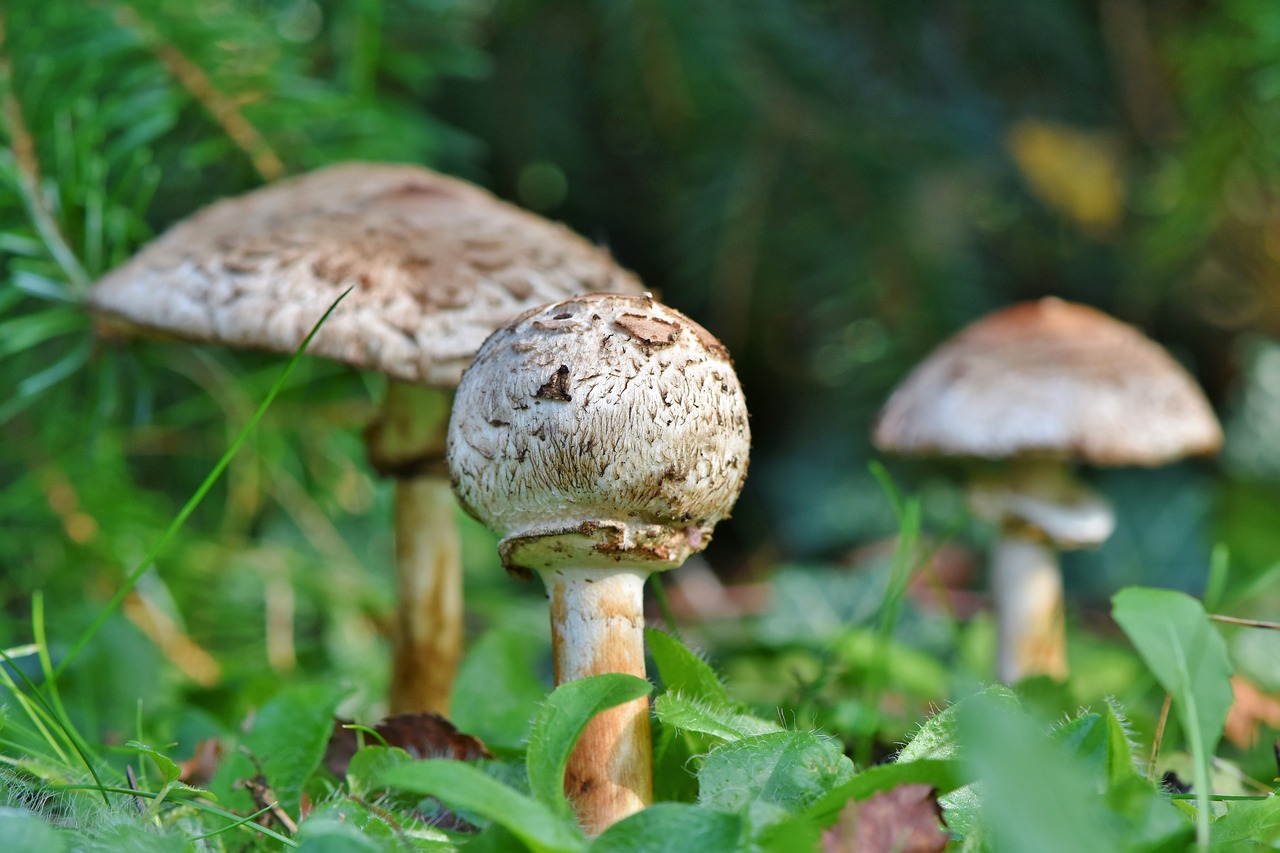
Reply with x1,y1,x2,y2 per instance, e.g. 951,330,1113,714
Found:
91,163,641,715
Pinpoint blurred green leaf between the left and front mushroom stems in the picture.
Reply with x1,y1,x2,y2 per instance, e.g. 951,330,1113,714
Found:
452,630,548,749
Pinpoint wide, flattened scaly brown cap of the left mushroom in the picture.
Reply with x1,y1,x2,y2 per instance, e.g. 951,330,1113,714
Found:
90,163,644,388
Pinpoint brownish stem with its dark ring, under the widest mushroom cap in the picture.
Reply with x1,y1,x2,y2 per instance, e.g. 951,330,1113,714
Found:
365,380,463,716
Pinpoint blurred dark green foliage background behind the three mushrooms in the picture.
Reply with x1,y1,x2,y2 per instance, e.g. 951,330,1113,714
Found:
0,0,1280,768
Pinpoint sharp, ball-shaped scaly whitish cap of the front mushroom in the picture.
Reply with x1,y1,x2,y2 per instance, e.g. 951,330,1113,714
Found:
448,293,750,573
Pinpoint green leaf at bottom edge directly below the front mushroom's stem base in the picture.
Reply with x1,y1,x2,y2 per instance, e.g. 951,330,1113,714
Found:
591,803,746,853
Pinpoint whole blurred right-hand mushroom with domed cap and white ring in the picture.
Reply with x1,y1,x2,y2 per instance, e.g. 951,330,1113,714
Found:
874,298,1222,683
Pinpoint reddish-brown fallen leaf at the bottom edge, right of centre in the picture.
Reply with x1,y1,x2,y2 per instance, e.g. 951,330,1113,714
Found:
822,784,951,853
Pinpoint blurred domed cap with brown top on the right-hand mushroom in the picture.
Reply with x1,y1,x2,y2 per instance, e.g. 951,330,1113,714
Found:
874,298,1222,465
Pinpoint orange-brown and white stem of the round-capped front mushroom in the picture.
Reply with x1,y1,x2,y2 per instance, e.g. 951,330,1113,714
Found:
541,569,653,835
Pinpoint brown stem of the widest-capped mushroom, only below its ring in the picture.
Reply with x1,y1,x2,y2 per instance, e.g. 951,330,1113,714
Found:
390,476,462,716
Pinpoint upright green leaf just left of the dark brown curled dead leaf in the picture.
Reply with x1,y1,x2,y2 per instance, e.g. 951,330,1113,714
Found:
244,684,347,815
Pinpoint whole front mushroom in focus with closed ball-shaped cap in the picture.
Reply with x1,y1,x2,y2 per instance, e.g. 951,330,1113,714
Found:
448,295,750,834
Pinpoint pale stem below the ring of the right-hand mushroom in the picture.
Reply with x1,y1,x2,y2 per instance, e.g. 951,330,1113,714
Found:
991,526,1066,684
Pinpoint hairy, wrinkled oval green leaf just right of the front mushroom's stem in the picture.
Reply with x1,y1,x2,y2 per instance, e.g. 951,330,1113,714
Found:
698,731,854,833
